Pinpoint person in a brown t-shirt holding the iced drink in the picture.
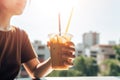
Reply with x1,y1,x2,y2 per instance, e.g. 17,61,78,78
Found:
0,0,75,80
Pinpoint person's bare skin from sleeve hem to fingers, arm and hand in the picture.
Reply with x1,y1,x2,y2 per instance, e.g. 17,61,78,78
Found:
23,42,75,78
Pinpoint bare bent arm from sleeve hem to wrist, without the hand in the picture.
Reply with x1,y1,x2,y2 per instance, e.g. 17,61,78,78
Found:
23,58,53,78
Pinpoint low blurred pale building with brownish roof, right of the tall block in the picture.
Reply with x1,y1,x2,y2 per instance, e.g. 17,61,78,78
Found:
90,45,116,71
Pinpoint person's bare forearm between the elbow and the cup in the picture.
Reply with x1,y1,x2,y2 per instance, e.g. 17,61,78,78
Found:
34,58,53,78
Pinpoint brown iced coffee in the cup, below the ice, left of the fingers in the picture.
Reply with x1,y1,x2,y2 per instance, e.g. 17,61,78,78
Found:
51,43,68,70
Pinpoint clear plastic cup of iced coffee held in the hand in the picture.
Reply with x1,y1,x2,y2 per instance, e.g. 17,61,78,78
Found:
49,34,72,70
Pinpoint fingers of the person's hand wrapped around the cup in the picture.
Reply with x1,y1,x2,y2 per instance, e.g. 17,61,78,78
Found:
61,42,75,67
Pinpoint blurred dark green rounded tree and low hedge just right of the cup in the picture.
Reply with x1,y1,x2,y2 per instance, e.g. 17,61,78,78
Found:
48,56,98,77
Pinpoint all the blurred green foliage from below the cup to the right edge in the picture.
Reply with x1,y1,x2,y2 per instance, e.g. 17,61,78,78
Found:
48,45,120,77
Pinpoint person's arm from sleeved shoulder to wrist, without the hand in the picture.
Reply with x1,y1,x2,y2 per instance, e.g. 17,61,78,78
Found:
20,30,52,78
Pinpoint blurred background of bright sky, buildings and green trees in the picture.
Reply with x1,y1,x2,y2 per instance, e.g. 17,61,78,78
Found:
11,0,120,77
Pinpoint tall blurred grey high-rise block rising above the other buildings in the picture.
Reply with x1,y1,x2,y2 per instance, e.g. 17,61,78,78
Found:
83,31,99,48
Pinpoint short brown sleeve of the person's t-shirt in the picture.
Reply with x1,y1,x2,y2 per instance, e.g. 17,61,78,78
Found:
21,31,37,63
